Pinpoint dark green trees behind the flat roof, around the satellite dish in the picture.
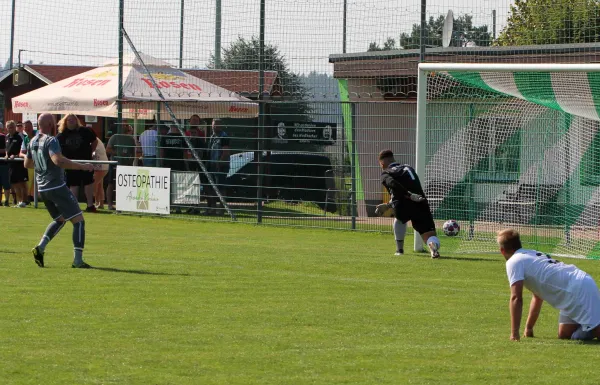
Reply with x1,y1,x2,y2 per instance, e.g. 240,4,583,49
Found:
369,14,492,51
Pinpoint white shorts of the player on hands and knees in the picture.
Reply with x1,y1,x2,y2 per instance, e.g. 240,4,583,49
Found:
558,275,600,331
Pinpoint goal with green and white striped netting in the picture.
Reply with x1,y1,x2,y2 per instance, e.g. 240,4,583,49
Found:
415,63,600,258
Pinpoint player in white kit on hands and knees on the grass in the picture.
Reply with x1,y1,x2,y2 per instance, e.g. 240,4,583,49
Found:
497,229,600,341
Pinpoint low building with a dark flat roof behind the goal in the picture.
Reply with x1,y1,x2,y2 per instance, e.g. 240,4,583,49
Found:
329,43,600,215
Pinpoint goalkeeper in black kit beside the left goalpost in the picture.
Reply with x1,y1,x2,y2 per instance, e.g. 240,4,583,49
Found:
375,150,440,259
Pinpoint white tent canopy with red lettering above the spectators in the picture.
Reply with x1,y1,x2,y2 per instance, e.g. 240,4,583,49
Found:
12,54,258,119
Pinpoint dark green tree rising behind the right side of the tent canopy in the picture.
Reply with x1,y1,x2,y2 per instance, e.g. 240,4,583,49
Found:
207,36,310,120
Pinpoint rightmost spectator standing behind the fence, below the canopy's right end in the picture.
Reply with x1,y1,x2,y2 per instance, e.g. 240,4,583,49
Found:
206,119,231,215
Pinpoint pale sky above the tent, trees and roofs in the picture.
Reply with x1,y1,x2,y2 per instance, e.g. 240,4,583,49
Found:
0,0,512,74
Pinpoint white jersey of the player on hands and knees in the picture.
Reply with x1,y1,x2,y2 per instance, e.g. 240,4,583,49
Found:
506,249,588,314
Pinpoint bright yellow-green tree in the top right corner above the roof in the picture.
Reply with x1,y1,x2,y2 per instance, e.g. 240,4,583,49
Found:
495,0,600,46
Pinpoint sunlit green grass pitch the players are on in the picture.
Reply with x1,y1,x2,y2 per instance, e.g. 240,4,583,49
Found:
0,208,600,385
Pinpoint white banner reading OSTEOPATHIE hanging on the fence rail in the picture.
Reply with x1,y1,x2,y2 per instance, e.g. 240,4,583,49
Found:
115,166,171,215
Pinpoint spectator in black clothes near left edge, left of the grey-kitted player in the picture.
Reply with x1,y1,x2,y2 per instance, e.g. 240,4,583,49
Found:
5,120,29,207
